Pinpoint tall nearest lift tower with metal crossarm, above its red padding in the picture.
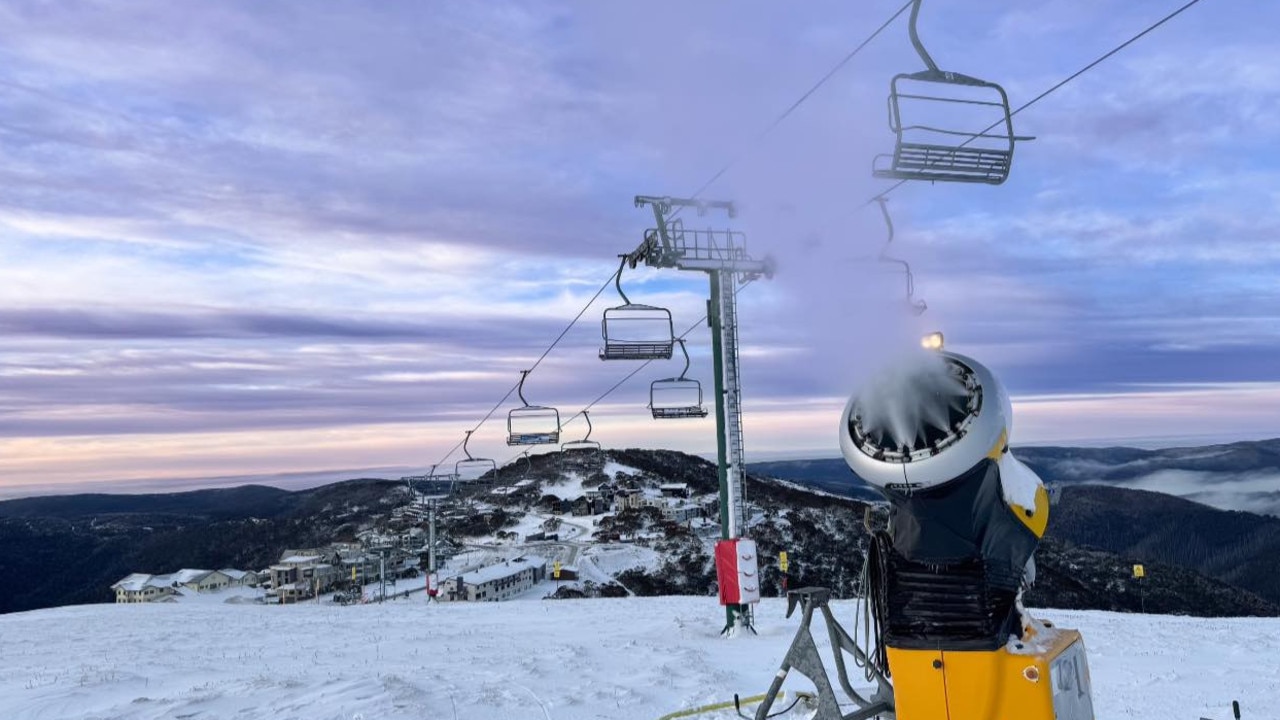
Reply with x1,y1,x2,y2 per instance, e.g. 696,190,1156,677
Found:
626,195,773,630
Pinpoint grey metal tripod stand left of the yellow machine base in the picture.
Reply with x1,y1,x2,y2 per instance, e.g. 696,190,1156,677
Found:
755,588,893,720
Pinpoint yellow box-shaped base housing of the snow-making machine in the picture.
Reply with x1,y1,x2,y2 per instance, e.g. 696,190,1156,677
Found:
887,625,1094,720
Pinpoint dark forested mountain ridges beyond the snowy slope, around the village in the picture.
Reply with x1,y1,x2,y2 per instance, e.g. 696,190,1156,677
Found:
0,440,1280,615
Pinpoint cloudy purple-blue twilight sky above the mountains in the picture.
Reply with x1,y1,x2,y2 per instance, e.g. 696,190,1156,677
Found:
0,0,1280,495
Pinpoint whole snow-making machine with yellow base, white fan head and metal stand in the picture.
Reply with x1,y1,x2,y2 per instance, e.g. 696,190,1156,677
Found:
755,336,1094,720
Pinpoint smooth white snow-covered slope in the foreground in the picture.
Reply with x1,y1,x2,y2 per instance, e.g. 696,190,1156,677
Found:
0,596,1280,720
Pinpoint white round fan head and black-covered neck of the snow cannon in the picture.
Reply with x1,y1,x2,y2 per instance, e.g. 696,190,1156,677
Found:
840,351,1048,650
